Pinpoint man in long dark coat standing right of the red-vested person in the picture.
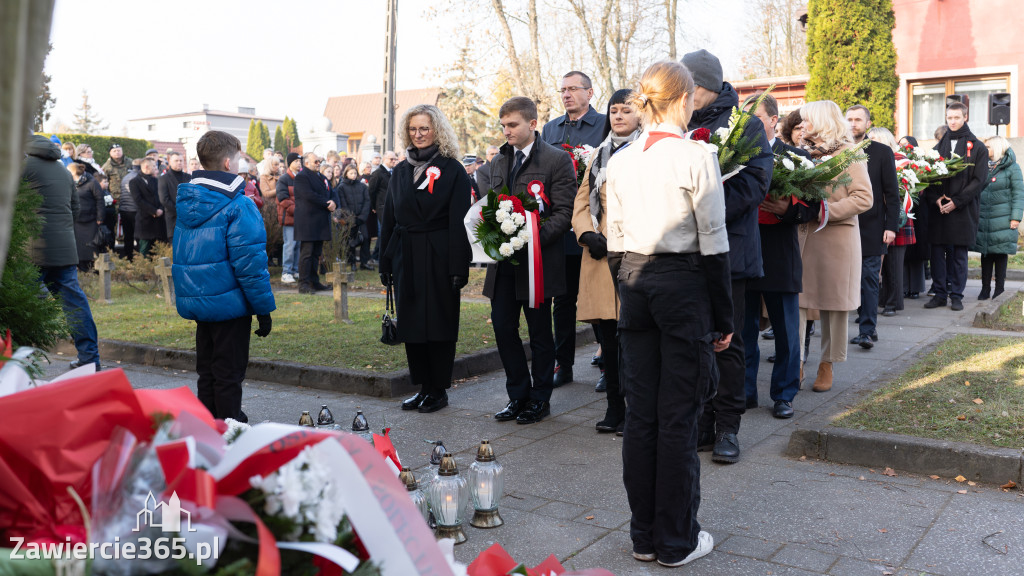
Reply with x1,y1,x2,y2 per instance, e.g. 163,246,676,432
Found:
294,152,338,294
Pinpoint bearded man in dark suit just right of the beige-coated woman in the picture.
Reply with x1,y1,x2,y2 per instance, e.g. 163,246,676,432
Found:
846,105,899,349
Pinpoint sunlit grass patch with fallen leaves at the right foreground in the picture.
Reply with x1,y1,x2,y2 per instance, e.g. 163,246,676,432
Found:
834,334,1024,448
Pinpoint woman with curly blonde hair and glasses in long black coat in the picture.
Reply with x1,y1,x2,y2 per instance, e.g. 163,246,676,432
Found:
380,105,472,412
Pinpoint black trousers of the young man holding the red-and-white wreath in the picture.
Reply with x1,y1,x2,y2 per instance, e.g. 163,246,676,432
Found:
490,262,555,402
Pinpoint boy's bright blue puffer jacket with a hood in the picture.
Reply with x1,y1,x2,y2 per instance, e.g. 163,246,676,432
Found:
172,170,276,322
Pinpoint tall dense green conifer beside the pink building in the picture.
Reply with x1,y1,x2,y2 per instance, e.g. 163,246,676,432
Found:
807,0,899,129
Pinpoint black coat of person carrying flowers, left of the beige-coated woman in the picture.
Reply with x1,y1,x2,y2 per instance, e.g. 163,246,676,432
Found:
748,138,821,293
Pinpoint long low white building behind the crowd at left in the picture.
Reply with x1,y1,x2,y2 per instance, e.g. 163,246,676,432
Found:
128,105,285,157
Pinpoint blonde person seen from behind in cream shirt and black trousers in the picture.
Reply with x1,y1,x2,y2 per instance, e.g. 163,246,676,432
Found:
606,61,733,566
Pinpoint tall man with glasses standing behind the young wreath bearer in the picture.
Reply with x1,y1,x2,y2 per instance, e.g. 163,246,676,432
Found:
541,70,604,387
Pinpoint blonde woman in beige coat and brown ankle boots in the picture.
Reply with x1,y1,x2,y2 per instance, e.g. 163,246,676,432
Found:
800,100,873,392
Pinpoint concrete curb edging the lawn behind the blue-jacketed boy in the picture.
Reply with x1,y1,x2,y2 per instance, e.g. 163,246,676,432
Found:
53,326,595,398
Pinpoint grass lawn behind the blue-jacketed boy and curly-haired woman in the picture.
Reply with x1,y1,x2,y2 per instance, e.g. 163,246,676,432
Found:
83,275,527,372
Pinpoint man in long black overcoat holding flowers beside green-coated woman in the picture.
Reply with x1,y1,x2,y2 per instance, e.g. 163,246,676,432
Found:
925,102,988,311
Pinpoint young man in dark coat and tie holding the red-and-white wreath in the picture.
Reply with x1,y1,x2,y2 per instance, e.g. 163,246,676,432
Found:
479,96,577,424
